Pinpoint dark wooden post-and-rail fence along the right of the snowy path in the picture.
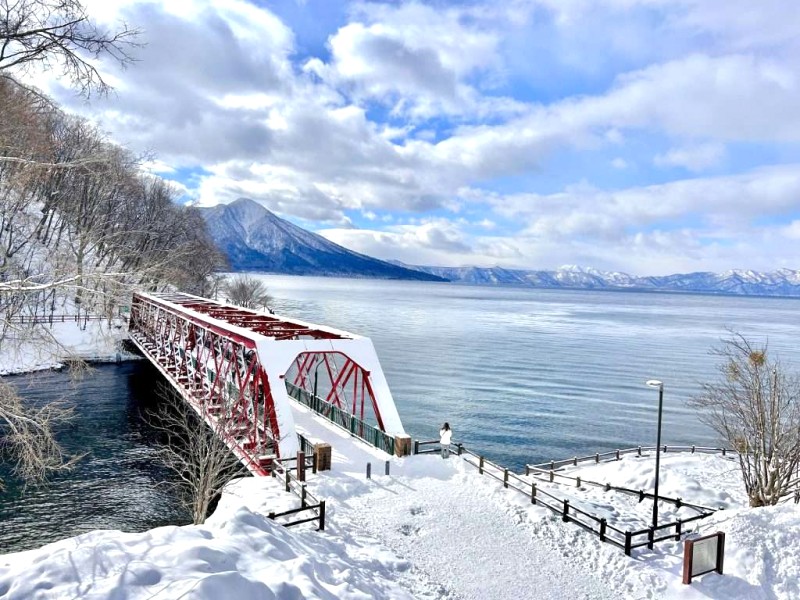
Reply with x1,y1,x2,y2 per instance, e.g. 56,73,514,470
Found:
414,440,725,556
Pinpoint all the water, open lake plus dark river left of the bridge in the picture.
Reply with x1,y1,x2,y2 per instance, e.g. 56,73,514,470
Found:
0,276,800,553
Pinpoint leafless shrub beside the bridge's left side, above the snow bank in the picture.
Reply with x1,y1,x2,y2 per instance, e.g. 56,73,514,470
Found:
149,389,245,525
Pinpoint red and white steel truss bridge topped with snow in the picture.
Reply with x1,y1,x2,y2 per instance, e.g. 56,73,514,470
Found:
129,293,408,475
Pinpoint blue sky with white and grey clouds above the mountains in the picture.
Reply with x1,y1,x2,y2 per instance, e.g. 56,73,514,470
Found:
28,0,800,275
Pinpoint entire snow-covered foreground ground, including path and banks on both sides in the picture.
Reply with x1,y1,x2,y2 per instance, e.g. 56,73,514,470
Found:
0,394,800,600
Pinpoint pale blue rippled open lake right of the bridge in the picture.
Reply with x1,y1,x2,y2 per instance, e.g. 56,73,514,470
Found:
255,276,800,469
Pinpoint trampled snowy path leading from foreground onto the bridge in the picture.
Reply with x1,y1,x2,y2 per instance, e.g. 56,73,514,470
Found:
295,400,615,600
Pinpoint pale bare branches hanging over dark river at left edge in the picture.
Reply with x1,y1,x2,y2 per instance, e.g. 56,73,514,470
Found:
0,380,78,489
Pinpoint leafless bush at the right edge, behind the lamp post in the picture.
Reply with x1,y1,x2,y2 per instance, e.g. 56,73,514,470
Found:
691,333,800,506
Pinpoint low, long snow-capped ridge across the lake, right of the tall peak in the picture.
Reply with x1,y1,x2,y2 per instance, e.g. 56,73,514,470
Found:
404,265,800,296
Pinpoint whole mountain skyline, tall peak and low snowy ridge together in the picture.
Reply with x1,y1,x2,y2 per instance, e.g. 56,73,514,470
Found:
200,198,800,296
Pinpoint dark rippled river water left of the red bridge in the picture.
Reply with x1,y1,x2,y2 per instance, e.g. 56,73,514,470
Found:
0,361,191,553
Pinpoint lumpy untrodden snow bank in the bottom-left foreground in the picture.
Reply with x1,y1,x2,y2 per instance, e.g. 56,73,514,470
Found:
0,507,411,600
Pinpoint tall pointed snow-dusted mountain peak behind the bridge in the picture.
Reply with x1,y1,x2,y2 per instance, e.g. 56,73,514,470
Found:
196,198,442,281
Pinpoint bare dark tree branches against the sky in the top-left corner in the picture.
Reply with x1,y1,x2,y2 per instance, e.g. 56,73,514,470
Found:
0,0,139,95
